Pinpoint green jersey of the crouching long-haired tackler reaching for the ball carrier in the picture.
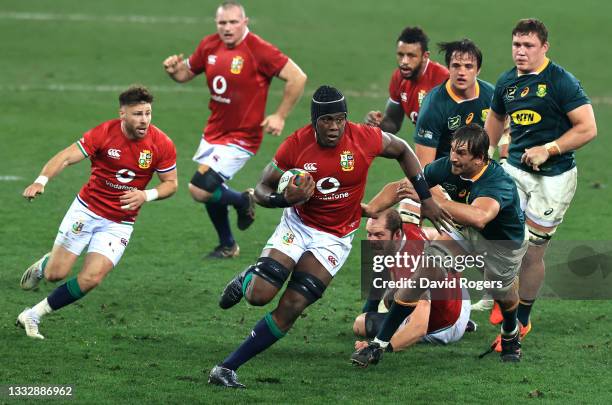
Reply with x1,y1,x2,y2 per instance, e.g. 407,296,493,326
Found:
424,157,525,243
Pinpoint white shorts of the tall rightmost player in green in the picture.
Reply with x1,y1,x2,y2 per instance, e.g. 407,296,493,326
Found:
503,163,578,227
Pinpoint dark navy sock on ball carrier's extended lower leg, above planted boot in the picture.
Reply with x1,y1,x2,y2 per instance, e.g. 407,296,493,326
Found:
221,313,285,370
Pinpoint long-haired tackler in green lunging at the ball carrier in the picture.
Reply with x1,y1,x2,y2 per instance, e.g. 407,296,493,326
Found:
351,124,528,367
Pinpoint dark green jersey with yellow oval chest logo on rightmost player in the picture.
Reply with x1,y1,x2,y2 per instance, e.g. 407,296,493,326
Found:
491,59,591,176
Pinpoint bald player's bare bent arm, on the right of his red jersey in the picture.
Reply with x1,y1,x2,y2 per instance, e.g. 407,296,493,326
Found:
261,59,307,135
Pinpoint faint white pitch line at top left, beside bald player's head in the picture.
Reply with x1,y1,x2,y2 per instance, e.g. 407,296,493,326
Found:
0,11,213,24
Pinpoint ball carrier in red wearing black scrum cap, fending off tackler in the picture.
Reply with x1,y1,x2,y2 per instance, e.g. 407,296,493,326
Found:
208,86,448,388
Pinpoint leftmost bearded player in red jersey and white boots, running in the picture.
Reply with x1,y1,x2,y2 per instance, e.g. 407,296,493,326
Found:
17,86,178,339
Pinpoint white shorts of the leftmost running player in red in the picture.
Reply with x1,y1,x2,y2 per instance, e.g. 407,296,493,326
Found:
55,198,134,266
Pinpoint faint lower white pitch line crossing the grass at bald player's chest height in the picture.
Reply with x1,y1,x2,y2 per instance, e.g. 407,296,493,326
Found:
0,83,612,105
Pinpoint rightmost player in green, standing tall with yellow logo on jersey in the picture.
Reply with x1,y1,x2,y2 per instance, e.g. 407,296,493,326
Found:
485,19,597,348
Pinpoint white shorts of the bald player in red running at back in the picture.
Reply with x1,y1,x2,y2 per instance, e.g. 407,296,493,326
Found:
193,138,253,180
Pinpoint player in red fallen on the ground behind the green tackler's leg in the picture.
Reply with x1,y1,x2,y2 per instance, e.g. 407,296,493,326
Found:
353,209,474,351
